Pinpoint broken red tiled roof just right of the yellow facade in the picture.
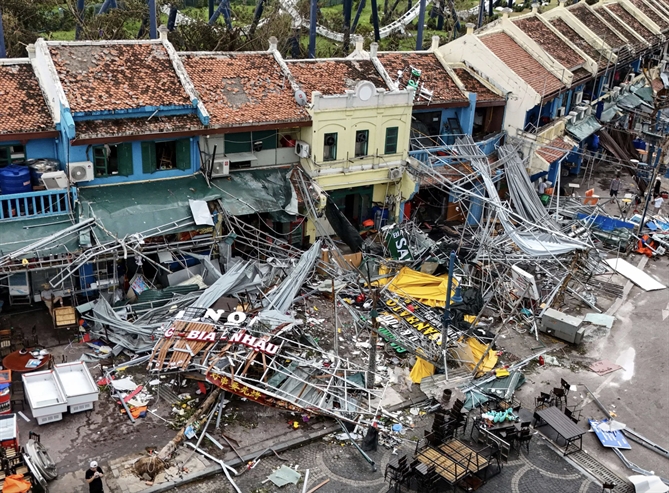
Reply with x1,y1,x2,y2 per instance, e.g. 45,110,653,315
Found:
378,52,469,106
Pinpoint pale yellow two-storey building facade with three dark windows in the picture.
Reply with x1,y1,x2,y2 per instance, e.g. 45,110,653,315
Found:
300,81,416,240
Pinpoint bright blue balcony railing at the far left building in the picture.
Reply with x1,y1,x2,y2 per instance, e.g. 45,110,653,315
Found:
0,188,76,221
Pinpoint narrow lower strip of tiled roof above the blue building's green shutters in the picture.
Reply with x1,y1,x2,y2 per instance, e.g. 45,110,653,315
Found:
75,114,204,140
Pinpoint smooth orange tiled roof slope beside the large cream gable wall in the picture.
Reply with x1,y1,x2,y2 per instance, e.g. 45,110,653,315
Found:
480,33,564,96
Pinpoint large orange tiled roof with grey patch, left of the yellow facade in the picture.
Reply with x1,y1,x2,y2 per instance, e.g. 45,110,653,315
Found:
182,53,310,128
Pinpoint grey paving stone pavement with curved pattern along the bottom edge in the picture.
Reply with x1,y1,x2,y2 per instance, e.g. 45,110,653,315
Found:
166,435,601,493
